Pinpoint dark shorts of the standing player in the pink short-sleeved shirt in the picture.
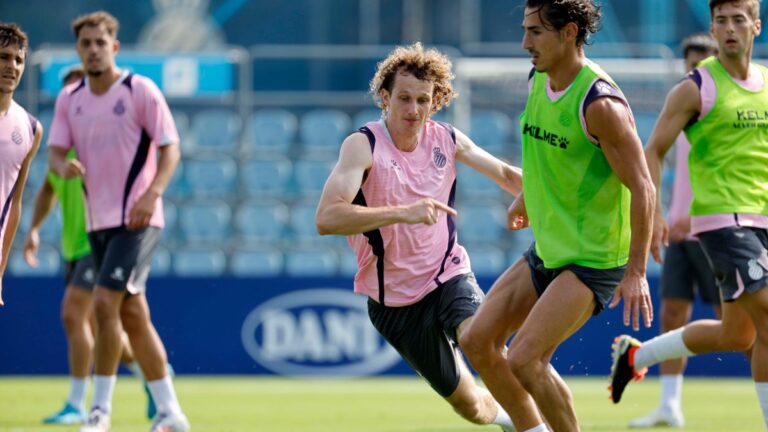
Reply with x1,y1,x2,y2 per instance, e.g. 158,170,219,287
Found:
88,227,162,294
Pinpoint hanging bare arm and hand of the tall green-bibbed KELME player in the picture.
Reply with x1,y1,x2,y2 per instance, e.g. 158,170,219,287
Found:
586,97,656,330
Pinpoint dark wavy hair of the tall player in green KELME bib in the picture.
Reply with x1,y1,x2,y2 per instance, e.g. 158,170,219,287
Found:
525,0,601,46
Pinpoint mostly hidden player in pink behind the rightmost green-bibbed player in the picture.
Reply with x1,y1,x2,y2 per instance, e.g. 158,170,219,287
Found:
629,33,721,428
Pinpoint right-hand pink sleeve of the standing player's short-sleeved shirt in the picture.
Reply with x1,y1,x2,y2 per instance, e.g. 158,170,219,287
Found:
136,77,179,146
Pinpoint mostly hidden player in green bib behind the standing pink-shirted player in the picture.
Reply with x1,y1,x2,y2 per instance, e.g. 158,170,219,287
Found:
24,66,154,424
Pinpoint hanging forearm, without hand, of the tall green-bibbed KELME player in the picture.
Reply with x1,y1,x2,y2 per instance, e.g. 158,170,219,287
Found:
627,181,656,276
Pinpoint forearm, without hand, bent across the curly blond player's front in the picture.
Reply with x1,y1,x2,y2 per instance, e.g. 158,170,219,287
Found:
316,203,406,235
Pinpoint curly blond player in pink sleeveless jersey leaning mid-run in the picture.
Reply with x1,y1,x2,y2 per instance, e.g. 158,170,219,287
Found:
316,42,521,430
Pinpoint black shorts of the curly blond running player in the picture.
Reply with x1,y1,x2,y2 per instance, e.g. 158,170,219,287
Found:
368,273,485,397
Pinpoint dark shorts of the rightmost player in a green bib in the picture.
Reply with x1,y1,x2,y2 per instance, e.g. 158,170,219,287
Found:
698,227,768,302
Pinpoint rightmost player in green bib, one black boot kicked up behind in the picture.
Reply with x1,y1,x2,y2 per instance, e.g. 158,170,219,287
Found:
611,0,768,426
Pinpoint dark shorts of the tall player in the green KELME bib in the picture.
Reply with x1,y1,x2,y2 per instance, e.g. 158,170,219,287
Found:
523,242,627,315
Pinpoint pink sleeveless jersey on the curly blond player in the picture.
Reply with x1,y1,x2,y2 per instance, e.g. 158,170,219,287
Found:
348,120,468,306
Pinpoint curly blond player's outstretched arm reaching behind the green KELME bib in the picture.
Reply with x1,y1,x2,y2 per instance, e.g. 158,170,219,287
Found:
455,130,523,196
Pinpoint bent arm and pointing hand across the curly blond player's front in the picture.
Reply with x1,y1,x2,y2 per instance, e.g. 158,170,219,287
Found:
315,133,456,235
